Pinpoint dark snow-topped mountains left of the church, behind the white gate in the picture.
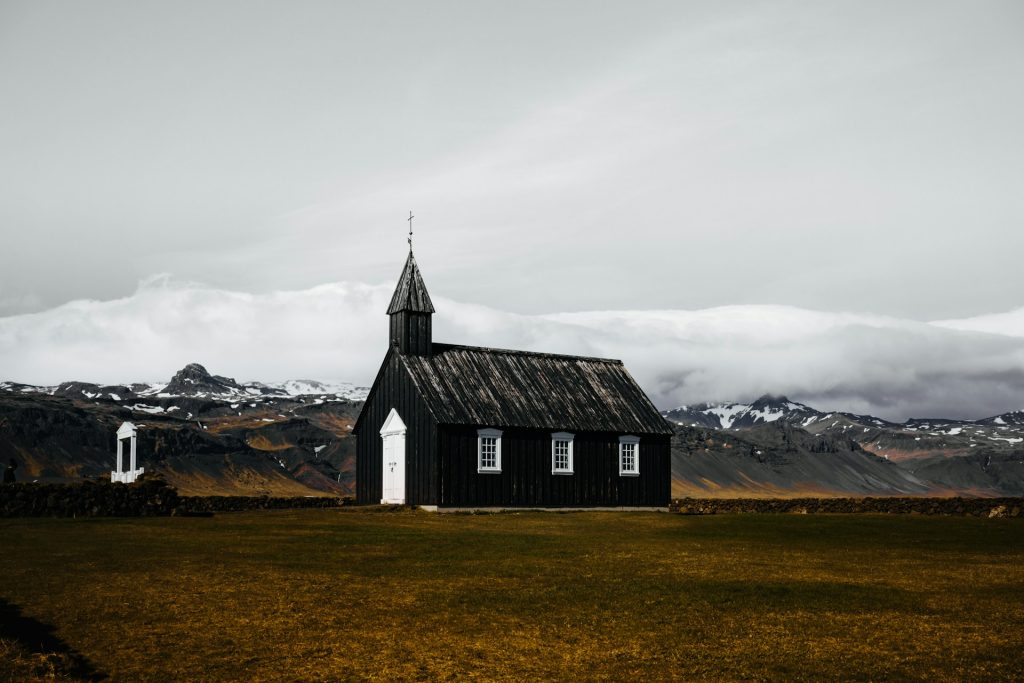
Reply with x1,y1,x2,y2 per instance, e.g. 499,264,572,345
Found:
0,364,368,496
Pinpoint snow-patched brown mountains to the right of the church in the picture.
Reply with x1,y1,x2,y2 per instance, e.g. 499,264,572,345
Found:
663,395,1024,497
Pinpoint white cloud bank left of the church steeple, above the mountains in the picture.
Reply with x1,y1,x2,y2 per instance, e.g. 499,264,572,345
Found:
0,278,390,384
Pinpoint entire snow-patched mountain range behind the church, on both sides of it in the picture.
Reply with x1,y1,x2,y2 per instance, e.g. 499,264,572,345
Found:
0,364,1024,497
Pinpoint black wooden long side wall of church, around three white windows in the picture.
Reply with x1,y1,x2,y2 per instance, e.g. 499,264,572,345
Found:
437,426,672,508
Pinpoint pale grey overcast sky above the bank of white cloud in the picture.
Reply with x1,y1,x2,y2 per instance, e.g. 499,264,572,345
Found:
0,0,1024,419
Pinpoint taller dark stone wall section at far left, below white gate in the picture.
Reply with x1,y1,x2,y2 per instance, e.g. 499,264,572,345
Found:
0,479,178,517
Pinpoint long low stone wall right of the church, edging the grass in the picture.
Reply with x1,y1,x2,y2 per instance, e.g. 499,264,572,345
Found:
670,498,1024,517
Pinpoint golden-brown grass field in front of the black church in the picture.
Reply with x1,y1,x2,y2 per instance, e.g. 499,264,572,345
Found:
0,510,1024,681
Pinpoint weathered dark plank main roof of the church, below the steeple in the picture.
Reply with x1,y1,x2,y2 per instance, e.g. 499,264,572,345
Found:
400,344,672,434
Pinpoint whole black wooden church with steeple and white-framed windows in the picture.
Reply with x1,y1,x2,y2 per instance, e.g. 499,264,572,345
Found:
352,249,672,509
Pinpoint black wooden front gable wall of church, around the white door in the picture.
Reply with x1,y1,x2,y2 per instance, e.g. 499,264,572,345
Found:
355,350,437,505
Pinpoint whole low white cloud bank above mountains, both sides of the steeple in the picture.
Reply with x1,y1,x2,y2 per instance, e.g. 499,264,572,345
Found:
0,278,1024,420
